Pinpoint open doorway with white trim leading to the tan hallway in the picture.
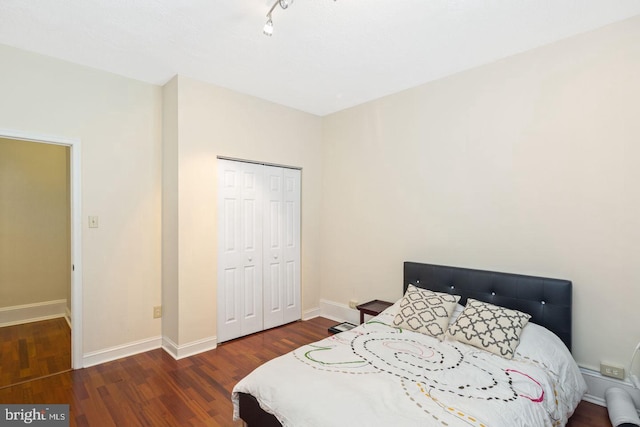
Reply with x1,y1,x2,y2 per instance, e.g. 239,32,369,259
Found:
0,129,82,388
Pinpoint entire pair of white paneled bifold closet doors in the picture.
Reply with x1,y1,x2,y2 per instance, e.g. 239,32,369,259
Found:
217,160,301,342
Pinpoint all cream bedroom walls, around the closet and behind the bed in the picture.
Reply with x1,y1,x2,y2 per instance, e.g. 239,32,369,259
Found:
0,18,640,367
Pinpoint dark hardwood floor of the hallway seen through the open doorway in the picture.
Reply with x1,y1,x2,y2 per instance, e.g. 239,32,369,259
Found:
0,317,71,387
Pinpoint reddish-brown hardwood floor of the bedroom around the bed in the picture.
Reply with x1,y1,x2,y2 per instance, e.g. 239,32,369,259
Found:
0,318,611,427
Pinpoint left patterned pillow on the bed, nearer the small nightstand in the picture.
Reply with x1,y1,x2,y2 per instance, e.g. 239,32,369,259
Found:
393,285,460,338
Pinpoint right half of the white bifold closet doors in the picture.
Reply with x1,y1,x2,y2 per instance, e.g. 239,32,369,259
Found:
263,166,301,329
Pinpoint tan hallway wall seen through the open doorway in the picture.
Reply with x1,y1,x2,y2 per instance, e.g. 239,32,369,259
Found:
0,138,71,308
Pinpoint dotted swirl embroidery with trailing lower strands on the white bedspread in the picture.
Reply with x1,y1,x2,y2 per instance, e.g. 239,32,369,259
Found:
294,327,545,427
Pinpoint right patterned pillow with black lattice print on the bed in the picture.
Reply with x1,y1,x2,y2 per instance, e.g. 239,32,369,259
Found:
447,298,531,359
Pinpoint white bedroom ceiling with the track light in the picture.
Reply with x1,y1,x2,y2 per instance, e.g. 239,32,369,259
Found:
0,0,640,116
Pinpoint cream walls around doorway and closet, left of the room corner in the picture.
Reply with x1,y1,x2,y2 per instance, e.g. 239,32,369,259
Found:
0,45,321,355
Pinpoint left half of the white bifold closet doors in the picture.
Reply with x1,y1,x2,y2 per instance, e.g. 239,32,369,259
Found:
217,160,263,342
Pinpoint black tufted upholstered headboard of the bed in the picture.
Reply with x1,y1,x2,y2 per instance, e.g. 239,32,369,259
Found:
404,262,572,350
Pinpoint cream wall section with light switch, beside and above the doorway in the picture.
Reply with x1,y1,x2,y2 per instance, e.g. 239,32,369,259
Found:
0,45,162,354
